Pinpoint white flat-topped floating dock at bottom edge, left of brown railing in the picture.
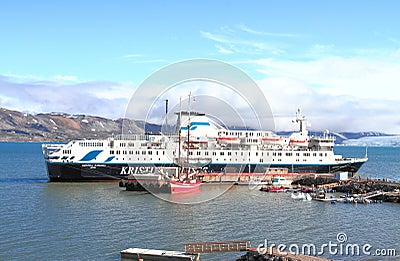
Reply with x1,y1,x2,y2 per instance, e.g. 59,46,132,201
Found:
121,248,199,261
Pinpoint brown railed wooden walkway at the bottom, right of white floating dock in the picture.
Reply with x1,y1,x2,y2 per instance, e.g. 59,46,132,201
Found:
184,240,250,254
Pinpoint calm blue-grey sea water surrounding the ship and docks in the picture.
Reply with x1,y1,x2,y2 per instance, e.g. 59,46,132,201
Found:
0,143,400,260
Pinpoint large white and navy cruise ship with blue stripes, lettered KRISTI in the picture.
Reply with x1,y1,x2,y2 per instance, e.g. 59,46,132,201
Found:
42,110,368,182
